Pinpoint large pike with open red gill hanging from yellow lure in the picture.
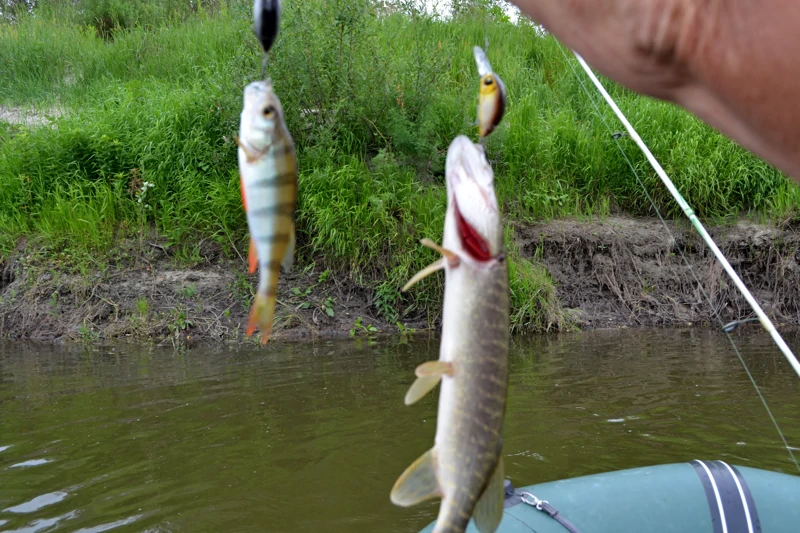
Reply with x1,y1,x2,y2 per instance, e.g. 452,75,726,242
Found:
391,135,509,533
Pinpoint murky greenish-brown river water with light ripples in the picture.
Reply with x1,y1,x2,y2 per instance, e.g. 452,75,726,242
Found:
0,330,800,533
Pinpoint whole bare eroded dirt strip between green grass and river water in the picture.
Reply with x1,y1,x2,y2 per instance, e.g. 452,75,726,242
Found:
0,217,800,343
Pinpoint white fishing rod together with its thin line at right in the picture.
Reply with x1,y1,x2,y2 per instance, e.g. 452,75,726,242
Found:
558,45,800,471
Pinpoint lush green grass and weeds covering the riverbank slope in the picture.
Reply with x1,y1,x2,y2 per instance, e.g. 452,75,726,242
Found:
0,0,800,329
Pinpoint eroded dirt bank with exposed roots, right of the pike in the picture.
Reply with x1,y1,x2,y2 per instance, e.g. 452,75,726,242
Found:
516,217,800,327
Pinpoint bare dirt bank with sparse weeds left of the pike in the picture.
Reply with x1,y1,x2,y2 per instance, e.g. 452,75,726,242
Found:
0,239,426,344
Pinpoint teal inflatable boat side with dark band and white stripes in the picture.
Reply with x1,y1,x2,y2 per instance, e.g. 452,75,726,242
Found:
421,460,800,533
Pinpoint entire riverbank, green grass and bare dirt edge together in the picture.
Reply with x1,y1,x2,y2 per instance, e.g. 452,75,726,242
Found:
0,0,800,342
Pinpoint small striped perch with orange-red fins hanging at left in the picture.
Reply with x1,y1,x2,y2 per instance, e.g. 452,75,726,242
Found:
236,80,297,344
